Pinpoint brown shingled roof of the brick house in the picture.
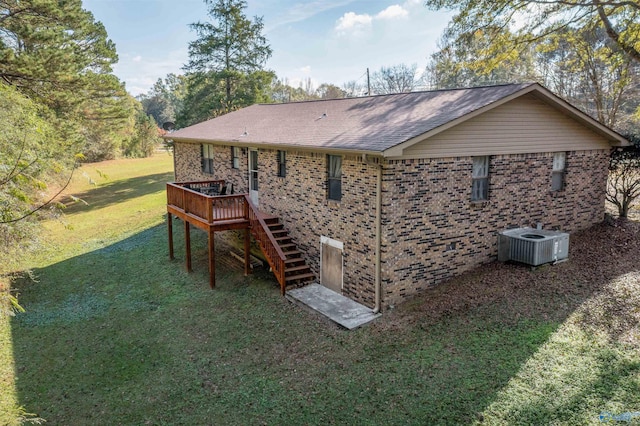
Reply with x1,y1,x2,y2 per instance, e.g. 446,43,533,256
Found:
165,83,623,154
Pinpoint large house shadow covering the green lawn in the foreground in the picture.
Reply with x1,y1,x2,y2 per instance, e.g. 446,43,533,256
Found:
6,220,638,425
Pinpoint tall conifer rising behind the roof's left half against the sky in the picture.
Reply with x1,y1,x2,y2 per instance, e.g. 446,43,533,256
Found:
185,0,271,114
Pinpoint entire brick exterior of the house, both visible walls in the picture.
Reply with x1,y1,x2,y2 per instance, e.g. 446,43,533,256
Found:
175,143,608,307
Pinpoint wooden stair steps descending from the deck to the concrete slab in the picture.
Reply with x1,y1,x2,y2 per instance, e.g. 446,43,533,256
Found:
265,216,316,287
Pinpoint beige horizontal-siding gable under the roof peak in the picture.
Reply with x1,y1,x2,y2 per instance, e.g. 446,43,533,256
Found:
399,95,610,158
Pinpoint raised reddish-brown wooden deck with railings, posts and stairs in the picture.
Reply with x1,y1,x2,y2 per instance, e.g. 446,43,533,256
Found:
167,180,314,295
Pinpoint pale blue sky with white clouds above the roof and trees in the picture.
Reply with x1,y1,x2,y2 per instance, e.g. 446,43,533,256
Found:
83,0,451,95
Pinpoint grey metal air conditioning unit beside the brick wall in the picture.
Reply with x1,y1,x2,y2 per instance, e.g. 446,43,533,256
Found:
498,228,569,266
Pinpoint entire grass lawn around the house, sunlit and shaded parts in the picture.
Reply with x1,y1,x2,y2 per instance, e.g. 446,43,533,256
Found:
0,154,640,425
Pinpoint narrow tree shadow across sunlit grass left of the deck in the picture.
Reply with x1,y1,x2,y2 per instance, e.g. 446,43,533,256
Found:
62,172,173,214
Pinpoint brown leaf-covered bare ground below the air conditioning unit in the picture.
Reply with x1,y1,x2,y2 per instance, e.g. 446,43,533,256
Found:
379,216,640,344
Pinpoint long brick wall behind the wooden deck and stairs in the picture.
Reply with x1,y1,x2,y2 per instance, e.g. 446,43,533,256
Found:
175,143,377,307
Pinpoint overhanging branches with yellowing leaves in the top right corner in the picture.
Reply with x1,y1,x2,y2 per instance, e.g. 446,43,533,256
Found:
425,0,640,62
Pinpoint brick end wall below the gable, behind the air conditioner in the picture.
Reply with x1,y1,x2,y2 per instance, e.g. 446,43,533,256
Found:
382,150,608,306
